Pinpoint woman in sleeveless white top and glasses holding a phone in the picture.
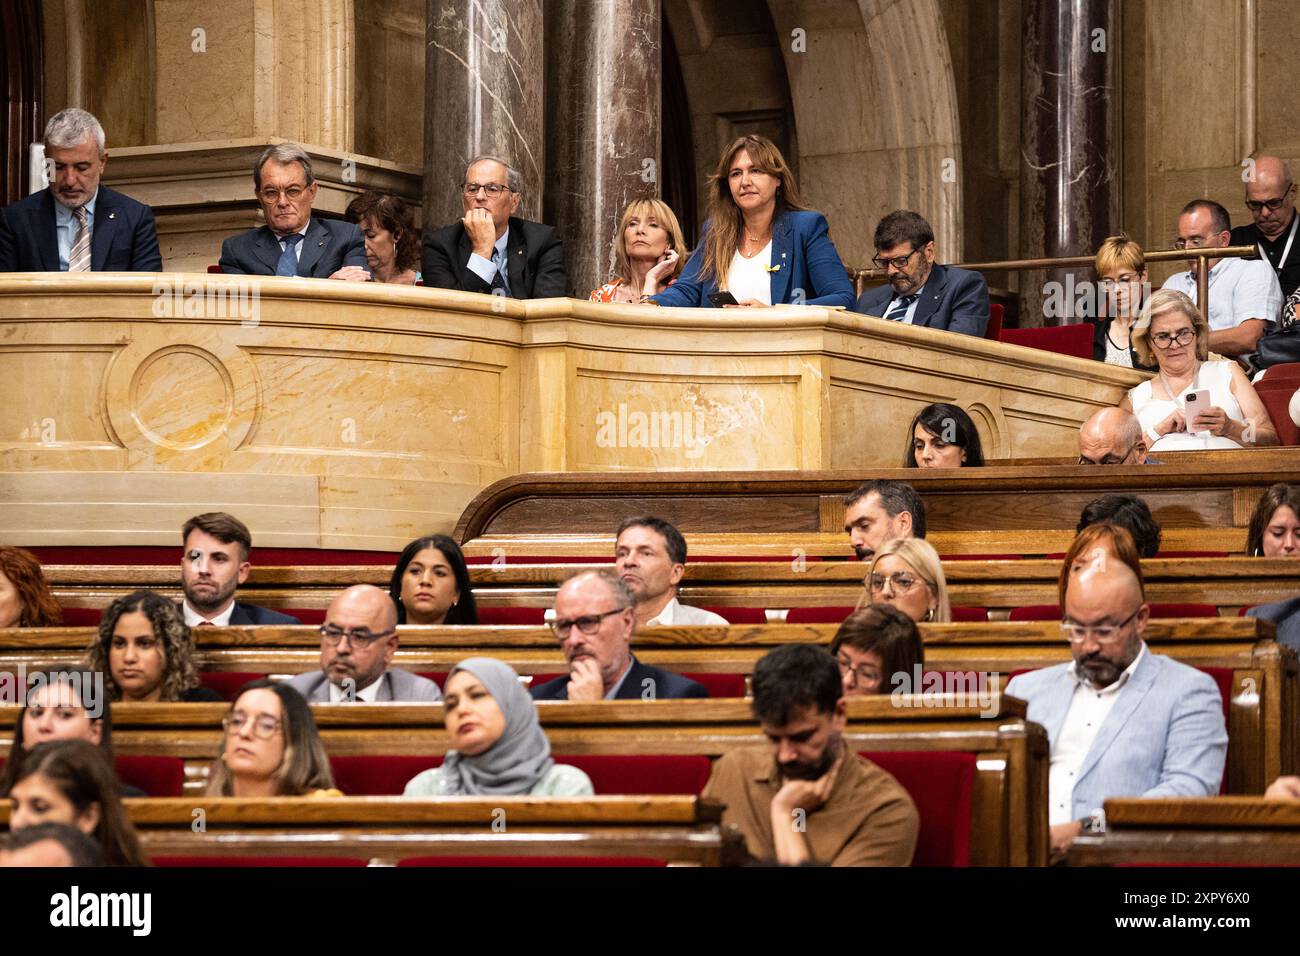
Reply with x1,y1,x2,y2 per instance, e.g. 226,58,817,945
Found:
1119,289,1278,451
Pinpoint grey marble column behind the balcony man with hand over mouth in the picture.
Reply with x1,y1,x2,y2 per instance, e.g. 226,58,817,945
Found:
424,0,546,228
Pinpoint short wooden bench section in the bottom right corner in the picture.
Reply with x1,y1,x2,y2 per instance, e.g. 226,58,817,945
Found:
1067,796,1300,868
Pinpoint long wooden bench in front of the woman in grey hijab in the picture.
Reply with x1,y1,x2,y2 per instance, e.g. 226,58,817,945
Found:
0,796,745,866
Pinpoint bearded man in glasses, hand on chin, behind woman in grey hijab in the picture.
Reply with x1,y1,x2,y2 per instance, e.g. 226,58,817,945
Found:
529,571,709,701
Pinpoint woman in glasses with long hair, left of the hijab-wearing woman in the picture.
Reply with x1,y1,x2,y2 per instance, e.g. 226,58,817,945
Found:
207,678,342,797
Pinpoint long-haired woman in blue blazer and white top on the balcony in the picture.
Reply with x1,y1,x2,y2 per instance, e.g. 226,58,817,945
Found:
645,135,854,308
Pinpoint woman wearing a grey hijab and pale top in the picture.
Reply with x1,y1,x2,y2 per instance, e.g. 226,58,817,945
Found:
404,657,594,797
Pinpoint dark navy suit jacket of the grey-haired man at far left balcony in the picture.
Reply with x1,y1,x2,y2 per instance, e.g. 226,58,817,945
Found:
0,186,163,272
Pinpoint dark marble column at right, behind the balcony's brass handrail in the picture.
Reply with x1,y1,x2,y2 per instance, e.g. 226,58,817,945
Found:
1021,0,1122,325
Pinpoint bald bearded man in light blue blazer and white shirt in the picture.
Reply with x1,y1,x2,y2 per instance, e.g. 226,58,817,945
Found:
1006,522,1227,862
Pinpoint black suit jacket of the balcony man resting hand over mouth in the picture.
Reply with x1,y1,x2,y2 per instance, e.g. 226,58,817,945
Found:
420,216,568,299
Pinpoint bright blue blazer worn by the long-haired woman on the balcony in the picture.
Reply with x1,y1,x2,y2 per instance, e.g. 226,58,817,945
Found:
654,211,853,308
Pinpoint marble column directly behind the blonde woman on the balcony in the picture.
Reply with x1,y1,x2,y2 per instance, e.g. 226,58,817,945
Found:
546,0,662,298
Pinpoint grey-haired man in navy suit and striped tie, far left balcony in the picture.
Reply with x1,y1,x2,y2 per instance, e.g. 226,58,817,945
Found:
0,109,163,272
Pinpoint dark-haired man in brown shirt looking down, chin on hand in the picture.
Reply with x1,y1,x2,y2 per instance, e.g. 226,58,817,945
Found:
705,644,920,866
